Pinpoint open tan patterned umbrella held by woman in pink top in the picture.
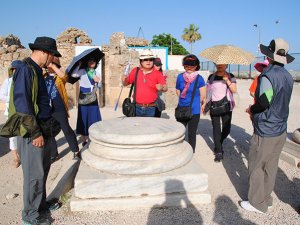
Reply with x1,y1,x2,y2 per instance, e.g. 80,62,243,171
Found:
200,45,256,65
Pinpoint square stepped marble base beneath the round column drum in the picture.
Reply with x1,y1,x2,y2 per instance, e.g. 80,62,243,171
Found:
70,157,211,211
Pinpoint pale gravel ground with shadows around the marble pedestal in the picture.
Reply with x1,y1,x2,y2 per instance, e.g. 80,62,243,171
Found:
0,80,300,225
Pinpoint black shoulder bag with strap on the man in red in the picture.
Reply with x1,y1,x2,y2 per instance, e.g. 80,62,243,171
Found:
122,67,139,117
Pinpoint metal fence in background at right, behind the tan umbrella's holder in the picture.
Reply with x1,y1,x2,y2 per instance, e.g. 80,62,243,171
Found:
200,53,300,81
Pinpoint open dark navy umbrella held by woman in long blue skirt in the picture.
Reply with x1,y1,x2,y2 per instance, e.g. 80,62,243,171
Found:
66,48,104,84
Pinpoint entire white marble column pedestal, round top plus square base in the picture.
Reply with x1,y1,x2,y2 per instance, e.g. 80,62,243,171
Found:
70,117,211,211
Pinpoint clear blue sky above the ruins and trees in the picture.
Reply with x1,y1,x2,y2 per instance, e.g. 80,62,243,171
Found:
0,0,300,55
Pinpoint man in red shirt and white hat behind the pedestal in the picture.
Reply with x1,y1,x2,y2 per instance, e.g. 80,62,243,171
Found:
122,49,168,117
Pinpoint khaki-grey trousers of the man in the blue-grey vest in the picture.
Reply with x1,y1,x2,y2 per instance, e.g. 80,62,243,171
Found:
248,132,286,212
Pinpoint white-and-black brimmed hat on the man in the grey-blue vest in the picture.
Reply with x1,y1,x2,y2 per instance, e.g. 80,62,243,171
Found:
260,38,295,64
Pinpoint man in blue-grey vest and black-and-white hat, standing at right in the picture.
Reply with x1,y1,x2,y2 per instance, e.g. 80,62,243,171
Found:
241,39,294,213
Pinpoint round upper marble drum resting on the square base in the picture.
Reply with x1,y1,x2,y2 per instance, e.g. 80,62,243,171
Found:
82,117,193,175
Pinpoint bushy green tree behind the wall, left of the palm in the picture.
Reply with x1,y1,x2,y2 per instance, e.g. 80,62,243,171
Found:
151,33,189,55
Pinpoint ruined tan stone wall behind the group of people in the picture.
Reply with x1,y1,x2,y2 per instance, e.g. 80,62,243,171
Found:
0,28,179,110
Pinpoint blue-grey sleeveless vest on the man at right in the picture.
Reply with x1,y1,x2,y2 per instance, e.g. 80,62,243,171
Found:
253,65,294,137
